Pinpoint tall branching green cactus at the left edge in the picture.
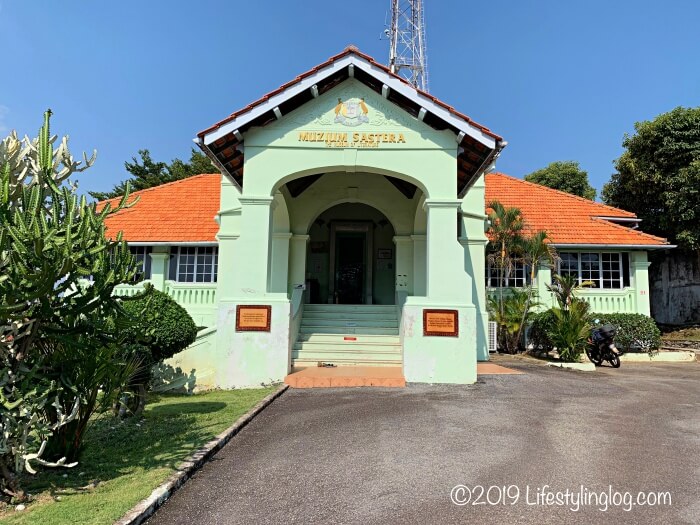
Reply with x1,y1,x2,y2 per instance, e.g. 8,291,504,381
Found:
0,111,136,499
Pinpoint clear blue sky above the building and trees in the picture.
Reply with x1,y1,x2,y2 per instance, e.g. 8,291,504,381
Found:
0,0,700,199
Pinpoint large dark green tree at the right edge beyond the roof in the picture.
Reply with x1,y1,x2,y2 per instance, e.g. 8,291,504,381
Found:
603,107,700,255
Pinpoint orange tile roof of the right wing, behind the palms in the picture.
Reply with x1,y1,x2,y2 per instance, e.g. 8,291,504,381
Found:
486,173,668,246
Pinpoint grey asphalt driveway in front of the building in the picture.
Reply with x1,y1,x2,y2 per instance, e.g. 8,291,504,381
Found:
149,360,700,525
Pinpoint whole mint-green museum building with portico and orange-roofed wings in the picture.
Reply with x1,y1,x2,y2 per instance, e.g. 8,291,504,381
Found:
109,48,667,388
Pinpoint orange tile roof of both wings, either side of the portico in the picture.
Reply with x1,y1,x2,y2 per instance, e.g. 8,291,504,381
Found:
100,173,668,246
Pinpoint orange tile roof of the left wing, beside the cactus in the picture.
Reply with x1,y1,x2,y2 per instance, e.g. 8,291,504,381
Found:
98,173,221,243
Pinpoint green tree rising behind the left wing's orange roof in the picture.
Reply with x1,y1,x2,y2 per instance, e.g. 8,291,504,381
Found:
89,148,218,201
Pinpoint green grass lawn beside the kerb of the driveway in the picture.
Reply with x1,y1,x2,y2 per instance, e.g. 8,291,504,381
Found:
0,387,276,525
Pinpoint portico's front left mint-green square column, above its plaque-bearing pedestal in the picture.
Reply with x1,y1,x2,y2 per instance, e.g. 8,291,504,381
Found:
226,196,273,297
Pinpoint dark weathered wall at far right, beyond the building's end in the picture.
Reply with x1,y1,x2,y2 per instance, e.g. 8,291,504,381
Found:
649,250,700,325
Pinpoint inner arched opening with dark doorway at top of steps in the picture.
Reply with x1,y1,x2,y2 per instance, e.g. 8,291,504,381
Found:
306,203,396,305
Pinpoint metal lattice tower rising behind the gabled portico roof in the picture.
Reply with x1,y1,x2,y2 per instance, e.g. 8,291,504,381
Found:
389,0,428,91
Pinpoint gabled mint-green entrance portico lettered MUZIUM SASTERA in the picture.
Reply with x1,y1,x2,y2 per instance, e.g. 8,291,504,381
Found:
197,48,503,386
